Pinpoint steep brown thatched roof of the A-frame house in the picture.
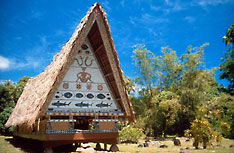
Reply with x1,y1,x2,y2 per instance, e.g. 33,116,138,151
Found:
5,3,134,127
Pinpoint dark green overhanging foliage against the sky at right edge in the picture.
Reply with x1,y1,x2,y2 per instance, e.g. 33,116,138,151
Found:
219,24,234,91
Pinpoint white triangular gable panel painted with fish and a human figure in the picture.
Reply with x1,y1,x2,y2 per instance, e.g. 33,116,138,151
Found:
47,40,118,112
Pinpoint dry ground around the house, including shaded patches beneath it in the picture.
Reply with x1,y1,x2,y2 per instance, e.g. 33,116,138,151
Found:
0,136,234,153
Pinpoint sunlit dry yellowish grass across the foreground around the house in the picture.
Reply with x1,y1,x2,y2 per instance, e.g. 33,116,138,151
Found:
0,136,234,153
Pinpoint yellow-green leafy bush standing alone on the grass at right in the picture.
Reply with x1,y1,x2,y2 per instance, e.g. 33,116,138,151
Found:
185,119,216,149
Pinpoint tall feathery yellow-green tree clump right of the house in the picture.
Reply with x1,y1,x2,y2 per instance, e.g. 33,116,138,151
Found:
131,44,220,136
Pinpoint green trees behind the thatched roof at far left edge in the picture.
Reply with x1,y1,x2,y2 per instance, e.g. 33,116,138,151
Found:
0,77,30,134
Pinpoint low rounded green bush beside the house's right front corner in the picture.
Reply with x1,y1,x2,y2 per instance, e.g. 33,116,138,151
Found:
119,125,145,143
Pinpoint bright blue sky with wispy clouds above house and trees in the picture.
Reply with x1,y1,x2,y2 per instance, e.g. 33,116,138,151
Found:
0,0,234,84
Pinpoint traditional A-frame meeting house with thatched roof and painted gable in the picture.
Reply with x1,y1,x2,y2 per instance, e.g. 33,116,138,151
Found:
6,3,134,152
